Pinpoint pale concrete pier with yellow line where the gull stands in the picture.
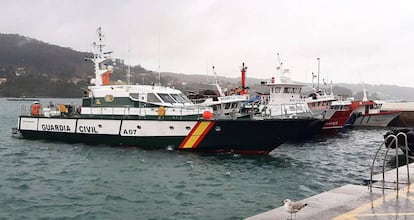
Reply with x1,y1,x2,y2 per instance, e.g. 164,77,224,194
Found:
247,163,414,220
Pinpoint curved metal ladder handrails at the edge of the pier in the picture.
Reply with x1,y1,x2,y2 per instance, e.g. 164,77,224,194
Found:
368,132,410,192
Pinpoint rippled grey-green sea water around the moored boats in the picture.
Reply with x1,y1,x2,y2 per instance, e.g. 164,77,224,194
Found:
0,99,402,220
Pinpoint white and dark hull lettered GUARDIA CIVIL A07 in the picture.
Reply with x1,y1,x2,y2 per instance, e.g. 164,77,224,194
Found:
18,116,320,154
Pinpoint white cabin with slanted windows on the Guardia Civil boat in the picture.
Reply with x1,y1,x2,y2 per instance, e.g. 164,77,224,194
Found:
81,85,212,118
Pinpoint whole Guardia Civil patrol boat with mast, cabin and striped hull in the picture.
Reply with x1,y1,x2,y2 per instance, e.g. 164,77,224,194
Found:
14,28,320,154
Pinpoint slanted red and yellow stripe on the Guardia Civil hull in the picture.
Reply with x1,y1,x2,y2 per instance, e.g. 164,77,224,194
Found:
180,121,214,148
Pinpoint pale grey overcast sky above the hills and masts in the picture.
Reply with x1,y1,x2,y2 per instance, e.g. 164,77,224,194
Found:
0,0,414,87
